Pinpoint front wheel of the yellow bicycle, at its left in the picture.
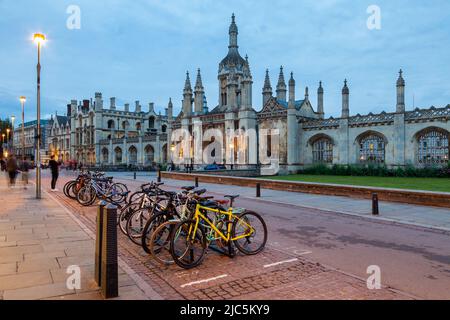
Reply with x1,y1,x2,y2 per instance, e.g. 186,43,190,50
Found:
170,220,206,269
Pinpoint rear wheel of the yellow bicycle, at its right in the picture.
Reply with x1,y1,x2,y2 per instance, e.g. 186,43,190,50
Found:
232,211,267,255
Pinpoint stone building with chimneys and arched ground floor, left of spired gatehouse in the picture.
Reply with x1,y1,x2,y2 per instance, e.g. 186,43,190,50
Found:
70,93,167,167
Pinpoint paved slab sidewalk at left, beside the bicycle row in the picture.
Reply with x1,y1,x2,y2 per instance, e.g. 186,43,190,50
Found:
0,173,146,300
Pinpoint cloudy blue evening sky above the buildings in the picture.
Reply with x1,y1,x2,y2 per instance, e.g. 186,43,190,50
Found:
0,0,450,123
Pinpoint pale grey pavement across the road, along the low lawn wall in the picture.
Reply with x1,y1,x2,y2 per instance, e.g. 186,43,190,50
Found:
112,173,450,232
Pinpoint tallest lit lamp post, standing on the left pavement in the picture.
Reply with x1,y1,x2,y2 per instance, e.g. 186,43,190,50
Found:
33,33,45,199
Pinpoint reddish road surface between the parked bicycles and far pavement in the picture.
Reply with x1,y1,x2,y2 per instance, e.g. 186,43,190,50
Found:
43,173,450,299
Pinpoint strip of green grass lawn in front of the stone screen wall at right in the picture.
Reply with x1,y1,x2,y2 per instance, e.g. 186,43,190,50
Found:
268,174,450,192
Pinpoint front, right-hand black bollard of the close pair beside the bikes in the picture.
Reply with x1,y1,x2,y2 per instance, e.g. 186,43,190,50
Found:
101,204,119,299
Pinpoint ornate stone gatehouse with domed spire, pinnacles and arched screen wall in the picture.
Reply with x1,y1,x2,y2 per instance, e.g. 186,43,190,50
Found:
167,15,450,173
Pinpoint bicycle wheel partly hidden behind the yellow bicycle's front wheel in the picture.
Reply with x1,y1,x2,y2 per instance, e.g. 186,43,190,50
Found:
150,220,180,266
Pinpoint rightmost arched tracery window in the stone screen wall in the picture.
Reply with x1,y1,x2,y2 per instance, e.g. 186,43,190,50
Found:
417,128,449,166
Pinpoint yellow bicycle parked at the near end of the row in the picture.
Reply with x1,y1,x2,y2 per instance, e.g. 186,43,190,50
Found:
170,196,267,269
